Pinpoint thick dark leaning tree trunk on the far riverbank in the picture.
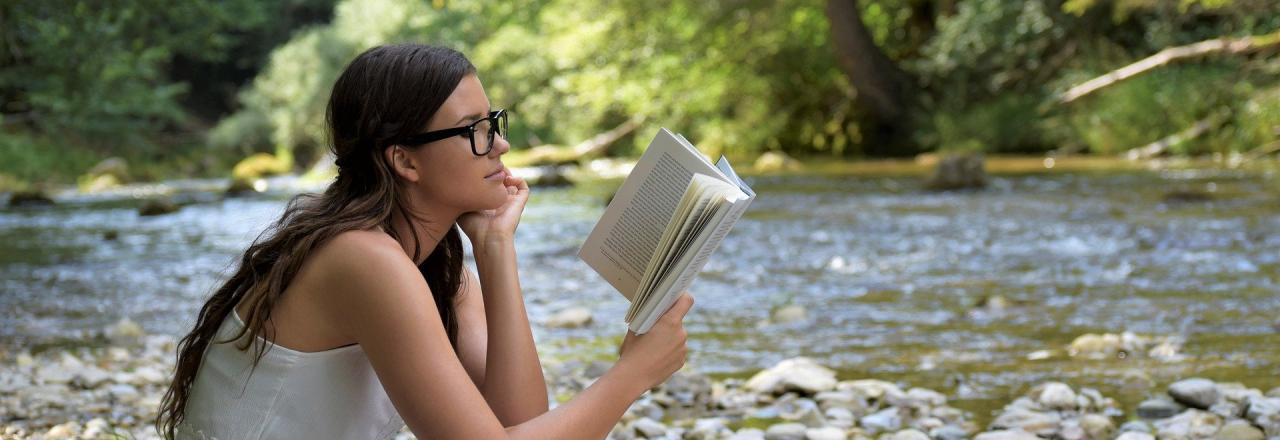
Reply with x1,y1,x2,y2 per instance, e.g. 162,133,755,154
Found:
827,0,914,150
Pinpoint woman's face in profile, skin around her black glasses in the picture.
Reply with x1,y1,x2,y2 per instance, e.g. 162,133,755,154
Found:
403,74,511,214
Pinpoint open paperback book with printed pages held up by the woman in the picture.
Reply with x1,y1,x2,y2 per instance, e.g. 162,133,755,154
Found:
579,128,755,334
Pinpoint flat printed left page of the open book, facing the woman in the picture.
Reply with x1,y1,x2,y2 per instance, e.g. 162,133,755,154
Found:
579,129,736,299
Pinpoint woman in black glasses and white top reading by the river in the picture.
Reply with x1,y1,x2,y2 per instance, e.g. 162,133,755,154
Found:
156,45,692,440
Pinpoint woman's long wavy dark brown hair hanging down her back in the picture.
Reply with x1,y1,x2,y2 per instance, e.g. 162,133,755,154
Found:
155,45,475,439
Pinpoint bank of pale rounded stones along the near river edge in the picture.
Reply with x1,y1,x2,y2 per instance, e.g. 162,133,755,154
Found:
0,320,1280,440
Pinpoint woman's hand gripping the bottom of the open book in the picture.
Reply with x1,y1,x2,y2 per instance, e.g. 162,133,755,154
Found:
616,292,694,390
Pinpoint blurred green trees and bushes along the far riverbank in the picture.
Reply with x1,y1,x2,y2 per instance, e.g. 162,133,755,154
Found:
0,0,1280,189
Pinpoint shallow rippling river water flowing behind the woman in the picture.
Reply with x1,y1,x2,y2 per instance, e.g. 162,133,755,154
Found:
0,159,1280,419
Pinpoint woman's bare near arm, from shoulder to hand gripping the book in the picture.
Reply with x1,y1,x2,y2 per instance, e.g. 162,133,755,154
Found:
314,233,692,440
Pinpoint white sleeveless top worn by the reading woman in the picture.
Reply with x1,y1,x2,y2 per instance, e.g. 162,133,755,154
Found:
177,310,404,440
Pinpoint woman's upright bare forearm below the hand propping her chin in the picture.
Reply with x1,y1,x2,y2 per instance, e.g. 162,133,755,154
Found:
471,235,547,426
